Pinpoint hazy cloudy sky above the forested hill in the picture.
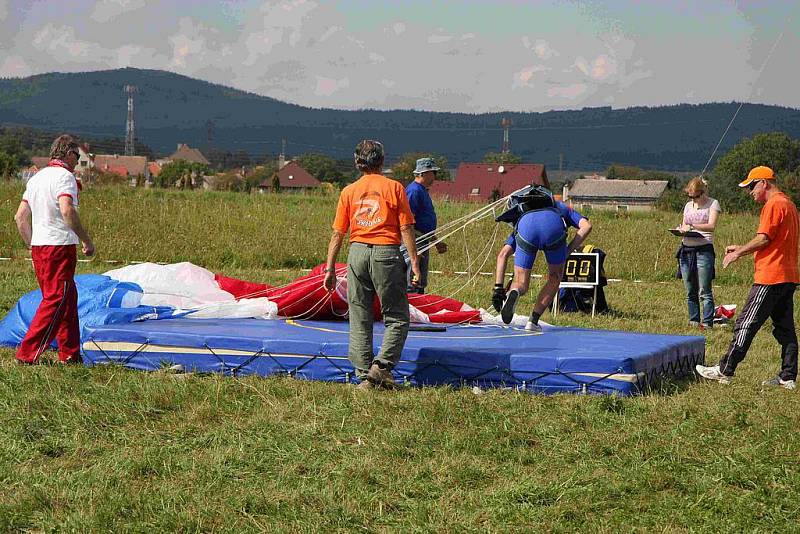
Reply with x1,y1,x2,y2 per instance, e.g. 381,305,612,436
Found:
0,0,800,113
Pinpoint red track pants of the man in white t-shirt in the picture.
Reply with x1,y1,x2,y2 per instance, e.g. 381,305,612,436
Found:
17,245,81,363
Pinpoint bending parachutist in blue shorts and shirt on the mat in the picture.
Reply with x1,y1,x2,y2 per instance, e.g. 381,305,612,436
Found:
492,201,592,333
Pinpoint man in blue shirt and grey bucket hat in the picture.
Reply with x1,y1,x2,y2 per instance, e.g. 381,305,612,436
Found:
406,158,447,294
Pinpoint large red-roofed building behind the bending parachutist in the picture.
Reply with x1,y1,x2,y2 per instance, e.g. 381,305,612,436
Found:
431,163,550,202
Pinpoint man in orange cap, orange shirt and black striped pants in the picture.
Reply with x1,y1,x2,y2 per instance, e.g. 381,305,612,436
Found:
697,167,800,389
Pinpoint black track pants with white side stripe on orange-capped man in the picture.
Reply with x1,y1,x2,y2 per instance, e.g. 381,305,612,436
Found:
719,284,797,380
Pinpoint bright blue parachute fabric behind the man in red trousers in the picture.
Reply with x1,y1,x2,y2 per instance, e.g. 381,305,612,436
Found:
0,274,173,347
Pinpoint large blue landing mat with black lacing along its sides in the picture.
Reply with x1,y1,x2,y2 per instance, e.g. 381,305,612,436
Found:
83,319,705,395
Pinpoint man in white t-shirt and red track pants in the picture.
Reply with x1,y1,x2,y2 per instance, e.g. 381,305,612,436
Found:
14,135,94,364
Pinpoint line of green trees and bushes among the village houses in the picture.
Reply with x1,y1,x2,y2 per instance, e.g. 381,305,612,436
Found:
0,127,800,212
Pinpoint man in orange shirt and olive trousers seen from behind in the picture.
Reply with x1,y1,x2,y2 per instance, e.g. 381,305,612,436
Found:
324,139,420,388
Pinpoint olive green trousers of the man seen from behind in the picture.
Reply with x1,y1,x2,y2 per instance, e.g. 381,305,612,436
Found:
347,243,409,378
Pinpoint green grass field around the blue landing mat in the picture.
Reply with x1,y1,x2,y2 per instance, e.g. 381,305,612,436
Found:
0,185,800,532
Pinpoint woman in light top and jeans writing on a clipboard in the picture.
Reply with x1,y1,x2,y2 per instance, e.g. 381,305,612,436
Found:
677,178,721,329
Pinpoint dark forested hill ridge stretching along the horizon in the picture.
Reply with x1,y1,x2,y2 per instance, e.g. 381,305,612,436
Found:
0,69,800,170
